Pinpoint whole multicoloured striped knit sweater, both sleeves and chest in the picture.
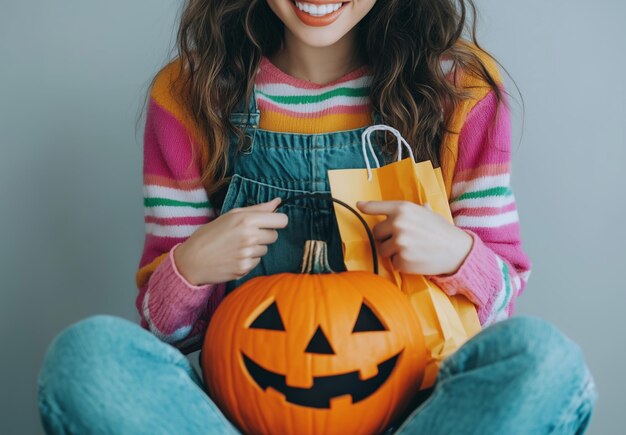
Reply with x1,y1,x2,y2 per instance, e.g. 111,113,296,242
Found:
136,53,531,348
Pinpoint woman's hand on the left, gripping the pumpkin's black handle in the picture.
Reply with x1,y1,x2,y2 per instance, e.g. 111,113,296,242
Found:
174,197,288,285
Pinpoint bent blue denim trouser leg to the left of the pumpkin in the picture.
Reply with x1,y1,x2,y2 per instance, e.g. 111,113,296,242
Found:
39,316,237,434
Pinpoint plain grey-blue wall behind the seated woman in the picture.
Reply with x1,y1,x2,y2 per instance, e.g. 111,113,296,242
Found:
0,0,626,434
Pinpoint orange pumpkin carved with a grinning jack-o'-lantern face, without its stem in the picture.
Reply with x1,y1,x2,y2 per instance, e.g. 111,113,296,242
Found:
202,272,426,433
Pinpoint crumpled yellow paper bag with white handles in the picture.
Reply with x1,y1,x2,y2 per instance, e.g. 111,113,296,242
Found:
328,125,480,389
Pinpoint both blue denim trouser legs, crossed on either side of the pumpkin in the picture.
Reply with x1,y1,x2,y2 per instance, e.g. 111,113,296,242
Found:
39,316,597,435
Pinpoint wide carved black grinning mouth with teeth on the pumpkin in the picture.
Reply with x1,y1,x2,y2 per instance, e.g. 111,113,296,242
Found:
241,351,402,409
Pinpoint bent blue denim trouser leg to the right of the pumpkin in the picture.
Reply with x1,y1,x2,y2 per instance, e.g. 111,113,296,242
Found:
398,317,597,435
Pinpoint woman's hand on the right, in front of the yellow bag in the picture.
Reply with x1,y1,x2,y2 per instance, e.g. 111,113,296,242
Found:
356,201,474,275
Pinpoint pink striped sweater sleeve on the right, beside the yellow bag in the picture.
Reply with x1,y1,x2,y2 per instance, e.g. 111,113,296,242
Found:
422,91,531,326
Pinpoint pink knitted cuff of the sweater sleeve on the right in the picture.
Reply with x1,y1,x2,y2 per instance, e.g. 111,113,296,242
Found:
427,228,502,307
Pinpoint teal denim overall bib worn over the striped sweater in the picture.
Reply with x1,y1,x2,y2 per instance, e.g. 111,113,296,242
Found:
221,89,390,292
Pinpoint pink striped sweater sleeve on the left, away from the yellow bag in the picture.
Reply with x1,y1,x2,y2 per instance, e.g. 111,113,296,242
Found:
136,99,224,349
